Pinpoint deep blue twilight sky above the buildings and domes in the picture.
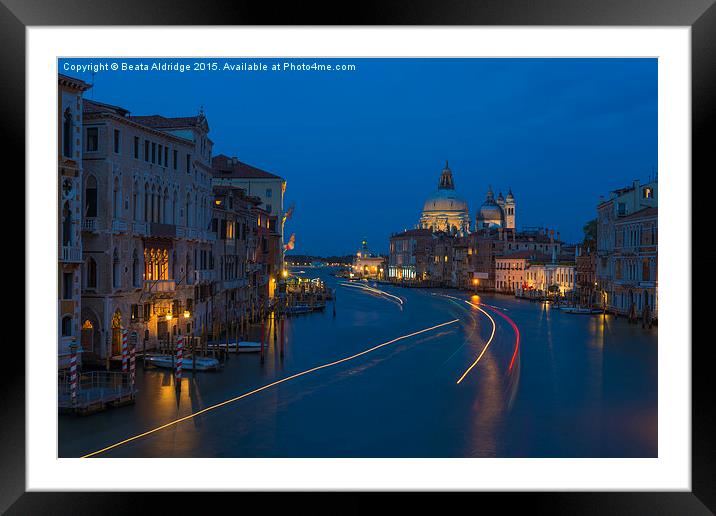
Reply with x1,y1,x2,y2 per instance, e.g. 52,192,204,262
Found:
59,58,657,255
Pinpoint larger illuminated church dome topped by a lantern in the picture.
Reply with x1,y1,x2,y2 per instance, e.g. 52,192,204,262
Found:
419,161,470,233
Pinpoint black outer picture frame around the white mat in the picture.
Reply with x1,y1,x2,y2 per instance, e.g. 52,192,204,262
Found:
0,0,716,514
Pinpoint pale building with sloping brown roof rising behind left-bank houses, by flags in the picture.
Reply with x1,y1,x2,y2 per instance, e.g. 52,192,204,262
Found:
211,154,286,266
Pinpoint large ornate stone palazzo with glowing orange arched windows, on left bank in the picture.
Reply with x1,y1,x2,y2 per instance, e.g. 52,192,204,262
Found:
82,100,213,364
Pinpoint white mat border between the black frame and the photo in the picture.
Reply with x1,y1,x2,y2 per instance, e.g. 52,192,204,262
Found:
26,27,691,491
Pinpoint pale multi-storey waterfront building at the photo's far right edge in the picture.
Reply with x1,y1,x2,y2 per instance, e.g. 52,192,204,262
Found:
609,207,658,321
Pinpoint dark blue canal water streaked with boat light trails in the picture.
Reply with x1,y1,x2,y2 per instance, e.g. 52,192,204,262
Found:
58,268,658,457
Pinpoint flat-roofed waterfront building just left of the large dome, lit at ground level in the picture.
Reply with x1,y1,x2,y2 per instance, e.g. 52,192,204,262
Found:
388,228,435,284
